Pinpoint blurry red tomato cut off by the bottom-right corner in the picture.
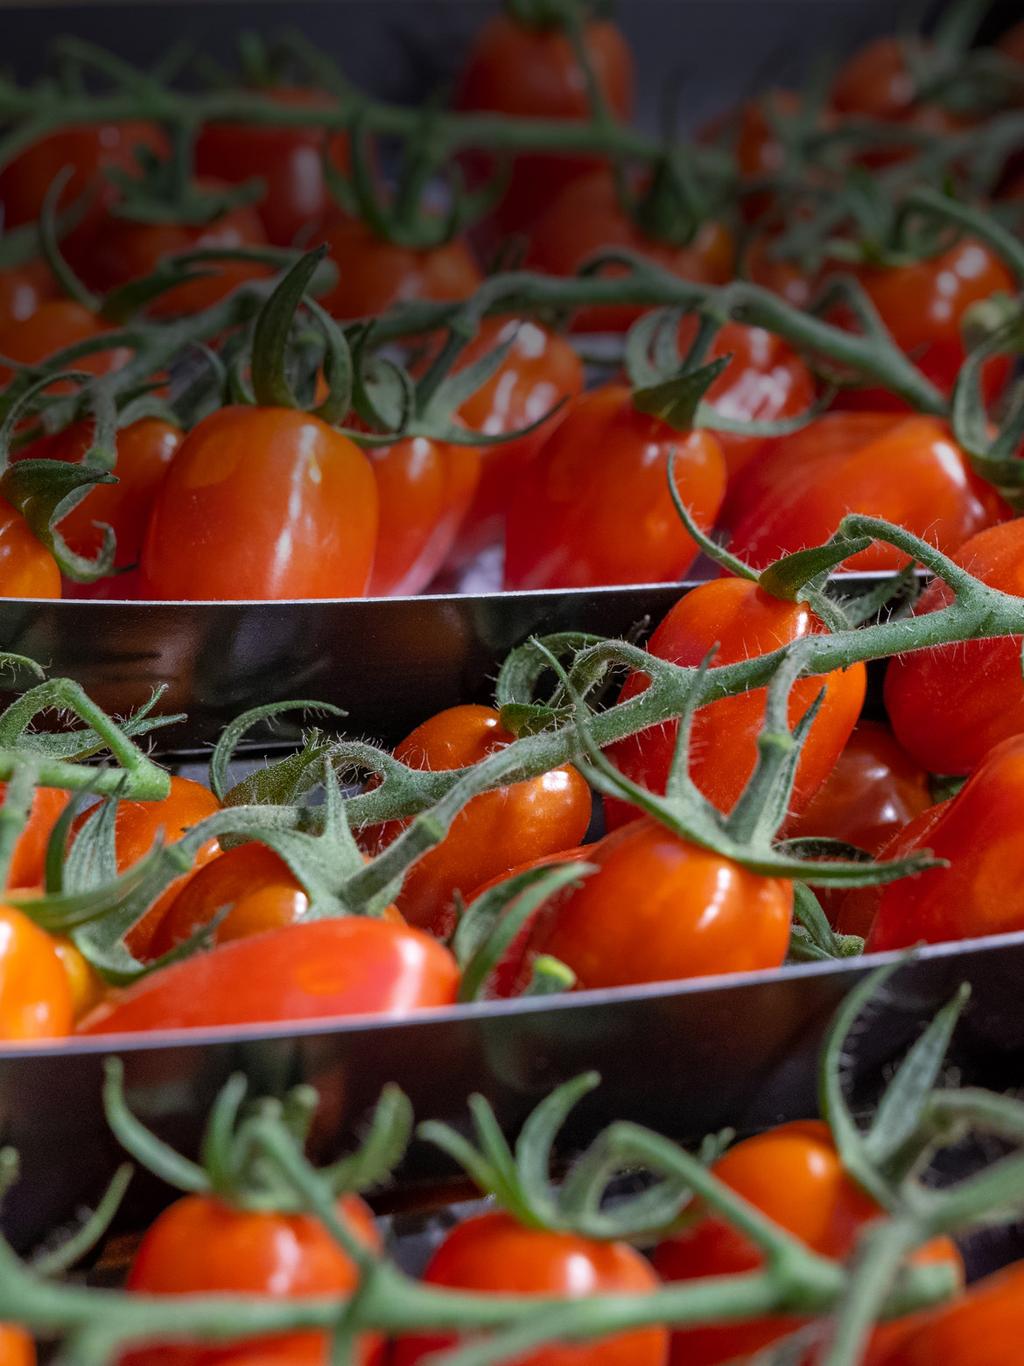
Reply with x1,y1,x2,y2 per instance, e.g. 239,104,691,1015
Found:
871,1262,1024,1366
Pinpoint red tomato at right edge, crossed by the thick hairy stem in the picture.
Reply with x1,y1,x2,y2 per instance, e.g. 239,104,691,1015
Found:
885,520,1024,773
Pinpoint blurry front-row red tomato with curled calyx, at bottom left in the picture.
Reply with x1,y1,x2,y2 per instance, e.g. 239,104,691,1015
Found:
120,1195,380,1366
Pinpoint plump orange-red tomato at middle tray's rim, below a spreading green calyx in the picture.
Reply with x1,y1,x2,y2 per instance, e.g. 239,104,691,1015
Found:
531,818,793,989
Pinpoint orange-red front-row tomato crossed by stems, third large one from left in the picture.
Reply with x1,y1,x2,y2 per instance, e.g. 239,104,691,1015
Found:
654,1120,961,1366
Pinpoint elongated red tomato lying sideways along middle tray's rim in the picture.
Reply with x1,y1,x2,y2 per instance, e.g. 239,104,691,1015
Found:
82,917,459,1034
